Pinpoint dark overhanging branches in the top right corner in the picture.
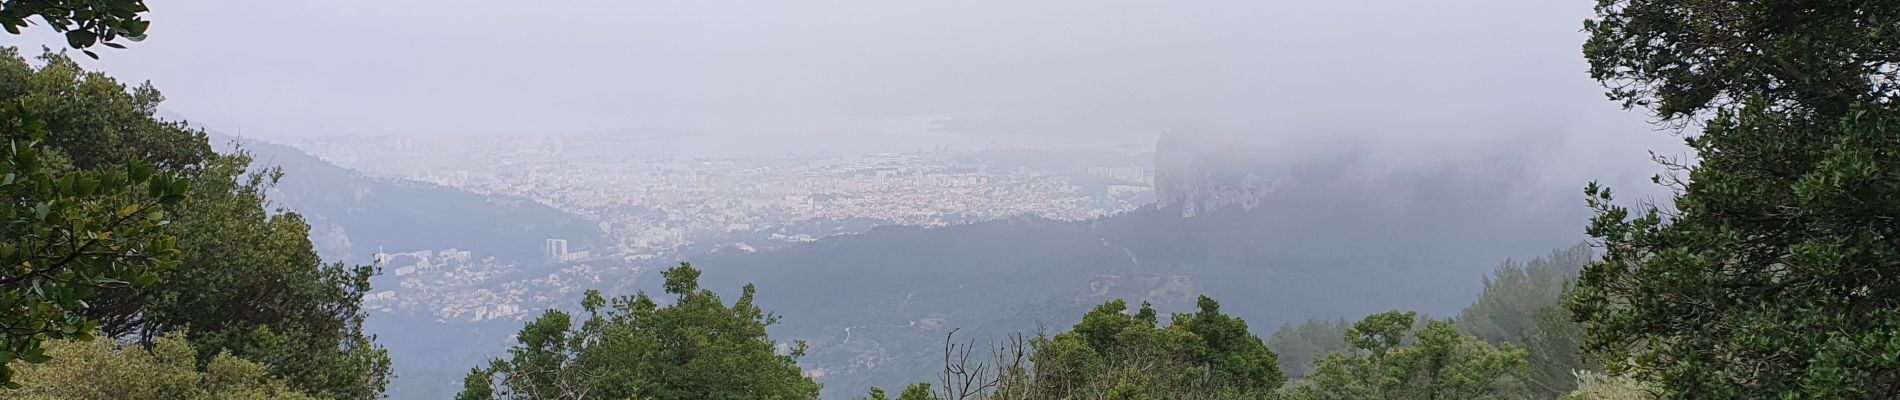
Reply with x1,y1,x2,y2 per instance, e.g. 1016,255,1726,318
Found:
1583,0,1900,119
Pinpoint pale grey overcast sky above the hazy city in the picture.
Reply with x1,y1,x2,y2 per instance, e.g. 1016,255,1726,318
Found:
6,0,1678,168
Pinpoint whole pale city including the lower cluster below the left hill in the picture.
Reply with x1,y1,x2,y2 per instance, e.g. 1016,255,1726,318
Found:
315,136,1153,322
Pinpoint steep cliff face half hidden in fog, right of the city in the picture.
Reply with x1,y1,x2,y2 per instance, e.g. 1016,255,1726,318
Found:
1155,133,1286,216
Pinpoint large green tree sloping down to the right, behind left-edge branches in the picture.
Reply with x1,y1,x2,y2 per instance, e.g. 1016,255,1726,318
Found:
0,47,390,398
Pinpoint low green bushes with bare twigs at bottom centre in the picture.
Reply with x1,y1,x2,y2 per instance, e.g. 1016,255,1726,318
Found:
868,296,1286,400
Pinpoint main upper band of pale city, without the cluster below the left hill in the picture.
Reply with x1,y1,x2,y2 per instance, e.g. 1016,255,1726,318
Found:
296,136,1153,256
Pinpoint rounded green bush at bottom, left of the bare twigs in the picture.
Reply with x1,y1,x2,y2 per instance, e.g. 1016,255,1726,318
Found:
456,264,819,400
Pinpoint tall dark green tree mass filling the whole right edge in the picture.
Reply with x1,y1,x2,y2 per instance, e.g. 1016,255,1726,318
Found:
1566,0,1900,398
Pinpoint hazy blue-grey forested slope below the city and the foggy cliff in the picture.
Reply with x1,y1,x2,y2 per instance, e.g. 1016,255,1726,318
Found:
691,141,1587,398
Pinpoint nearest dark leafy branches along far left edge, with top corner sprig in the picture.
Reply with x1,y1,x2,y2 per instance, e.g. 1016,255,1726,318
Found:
0,0,176,387
